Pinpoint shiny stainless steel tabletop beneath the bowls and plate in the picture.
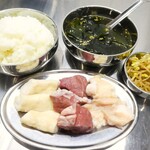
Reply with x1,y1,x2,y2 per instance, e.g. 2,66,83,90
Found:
0,0,150,150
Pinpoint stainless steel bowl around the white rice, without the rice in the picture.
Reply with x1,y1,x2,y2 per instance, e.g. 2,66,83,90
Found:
0,8,58,76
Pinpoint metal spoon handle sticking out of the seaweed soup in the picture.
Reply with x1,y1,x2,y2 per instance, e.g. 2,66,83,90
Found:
107,0,144,30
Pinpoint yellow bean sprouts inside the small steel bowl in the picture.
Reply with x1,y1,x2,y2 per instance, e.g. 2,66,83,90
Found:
126,53,150,92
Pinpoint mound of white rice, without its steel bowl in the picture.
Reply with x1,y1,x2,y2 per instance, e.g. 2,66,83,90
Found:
0,16,54,64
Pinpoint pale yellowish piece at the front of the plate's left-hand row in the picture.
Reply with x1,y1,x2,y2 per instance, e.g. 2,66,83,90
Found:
21,110,59,134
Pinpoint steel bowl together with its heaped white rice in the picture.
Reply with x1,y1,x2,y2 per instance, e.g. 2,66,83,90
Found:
0,8,58,76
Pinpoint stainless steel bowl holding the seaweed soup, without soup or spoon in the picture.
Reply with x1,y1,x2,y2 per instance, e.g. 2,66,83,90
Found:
62,6,138,67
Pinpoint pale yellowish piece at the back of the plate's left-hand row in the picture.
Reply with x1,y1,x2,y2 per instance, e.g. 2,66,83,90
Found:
20,79,59,95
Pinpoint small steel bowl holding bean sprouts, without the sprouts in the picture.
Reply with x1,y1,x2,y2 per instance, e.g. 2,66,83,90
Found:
121,52,150,99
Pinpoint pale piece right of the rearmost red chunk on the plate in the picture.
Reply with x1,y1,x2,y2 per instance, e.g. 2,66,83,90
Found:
86,75,116,99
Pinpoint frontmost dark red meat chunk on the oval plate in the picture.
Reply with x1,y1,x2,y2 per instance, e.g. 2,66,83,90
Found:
57,104,93,134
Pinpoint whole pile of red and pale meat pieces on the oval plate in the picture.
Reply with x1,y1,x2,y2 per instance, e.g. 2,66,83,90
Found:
15,75,134,134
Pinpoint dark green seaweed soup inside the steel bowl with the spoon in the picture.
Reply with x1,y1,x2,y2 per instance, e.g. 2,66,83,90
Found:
65,15,133,55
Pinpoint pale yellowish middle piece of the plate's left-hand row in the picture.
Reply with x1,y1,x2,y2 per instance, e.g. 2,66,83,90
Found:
14,94,53,112
